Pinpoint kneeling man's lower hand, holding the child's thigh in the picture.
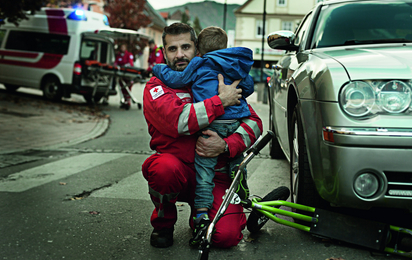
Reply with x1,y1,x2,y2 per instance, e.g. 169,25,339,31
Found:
196,130,226,157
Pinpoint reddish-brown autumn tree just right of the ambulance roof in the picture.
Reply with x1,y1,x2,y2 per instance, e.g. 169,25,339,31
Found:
104,0,151,30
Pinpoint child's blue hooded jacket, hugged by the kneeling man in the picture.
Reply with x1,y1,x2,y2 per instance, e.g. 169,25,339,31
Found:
153,47,254,120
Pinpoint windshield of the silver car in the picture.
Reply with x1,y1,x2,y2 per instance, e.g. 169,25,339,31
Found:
312,1,412,48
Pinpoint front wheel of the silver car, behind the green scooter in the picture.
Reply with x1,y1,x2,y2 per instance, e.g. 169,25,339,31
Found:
289,106,325,222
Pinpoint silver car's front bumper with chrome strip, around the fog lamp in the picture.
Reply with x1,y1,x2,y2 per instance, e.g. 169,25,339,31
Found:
320,129,412,210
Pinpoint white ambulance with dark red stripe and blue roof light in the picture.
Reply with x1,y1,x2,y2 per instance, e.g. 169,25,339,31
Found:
0,8,117,102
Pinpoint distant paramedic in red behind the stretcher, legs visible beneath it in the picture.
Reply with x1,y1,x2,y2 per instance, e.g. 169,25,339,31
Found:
114,44,134,109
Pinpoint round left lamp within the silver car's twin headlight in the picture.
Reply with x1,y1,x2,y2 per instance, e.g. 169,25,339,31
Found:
339,81,375,117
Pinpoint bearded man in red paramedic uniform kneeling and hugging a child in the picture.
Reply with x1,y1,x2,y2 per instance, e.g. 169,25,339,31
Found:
142,23,262,248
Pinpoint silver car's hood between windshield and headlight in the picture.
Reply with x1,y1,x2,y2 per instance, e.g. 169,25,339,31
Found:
324,45,412,80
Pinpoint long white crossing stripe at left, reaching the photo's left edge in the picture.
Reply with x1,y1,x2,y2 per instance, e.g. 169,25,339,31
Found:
0,153,126,192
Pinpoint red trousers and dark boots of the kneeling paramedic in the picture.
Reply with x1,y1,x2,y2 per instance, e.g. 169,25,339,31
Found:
142,153,246,248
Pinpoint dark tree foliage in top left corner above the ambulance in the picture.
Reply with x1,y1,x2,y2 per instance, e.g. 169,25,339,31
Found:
0,0,45,25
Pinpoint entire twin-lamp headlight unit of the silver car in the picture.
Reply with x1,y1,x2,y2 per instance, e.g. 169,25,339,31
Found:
339,80,412,117
